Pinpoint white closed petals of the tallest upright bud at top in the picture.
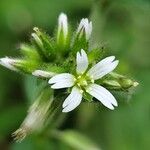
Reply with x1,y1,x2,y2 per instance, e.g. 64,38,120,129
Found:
58,13,68,39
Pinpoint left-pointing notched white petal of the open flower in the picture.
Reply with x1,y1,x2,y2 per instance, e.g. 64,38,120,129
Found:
48,73,75,89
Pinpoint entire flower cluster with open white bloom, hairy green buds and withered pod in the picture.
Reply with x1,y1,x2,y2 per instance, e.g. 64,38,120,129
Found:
0,13,138,140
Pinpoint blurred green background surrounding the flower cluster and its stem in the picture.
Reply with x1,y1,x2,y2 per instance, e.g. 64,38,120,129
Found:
0,0,150,150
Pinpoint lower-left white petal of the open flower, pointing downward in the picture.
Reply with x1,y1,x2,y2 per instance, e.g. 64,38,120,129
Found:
62,87,82,112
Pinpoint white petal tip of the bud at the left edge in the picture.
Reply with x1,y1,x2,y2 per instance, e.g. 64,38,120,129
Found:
0,57,18,71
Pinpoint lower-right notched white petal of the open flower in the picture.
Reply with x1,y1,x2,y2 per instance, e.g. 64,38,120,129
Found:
86,84,118,110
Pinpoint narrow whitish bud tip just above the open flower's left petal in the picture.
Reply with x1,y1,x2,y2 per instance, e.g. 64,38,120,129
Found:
32,70,56,78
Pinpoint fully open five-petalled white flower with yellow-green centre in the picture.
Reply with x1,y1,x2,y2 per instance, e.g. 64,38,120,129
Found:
49,49,119,112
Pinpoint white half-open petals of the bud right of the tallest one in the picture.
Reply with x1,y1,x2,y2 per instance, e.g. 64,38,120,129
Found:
77,18,92,40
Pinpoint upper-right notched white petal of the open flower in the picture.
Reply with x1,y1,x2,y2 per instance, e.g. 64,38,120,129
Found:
87,56,119,80
